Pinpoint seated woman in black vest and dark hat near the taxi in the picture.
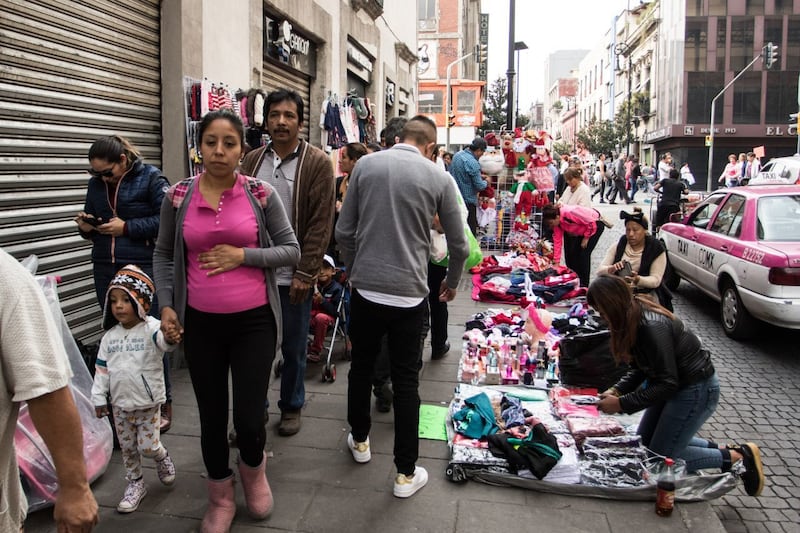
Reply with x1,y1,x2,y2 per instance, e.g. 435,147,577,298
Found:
597,208,672,311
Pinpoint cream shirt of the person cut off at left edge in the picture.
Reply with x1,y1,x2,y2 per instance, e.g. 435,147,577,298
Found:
0,250,72,531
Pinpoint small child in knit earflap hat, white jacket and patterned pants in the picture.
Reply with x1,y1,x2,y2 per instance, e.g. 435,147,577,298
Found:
92,265,181,513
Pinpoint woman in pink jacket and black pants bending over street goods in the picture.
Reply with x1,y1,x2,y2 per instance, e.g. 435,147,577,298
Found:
542,205,605,287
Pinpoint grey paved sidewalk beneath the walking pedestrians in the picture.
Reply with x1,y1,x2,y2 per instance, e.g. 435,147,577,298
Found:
25,206,725,533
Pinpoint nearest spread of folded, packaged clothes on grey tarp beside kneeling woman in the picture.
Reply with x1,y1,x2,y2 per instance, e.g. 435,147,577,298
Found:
446,384,736,502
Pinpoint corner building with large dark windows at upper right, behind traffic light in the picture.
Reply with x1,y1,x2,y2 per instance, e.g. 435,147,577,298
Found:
643,0,800,187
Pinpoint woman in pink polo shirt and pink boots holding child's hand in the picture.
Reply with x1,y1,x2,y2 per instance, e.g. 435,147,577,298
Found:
153,110,300,531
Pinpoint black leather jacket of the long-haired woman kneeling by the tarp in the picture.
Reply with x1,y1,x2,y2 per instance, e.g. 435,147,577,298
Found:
614,309,714,413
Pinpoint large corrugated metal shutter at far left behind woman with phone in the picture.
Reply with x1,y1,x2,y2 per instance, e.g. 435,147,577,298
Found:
0,0,161,340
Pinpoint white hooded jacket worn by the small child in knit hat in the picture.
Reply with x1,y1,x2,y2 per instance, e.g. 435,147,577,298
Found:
92,316,178,411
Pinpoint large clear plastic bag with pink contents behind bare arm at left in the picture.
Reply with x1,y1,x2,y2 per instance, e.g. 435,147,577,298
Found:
14,256,113,512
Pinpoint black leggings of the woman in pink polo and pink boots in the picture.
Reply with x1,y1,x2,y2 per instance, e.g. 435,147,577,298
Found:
184,305,277,479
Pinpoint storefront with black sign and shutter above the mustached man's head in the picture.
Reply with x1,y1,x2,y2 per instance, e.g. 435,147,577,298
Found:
262,10,317,139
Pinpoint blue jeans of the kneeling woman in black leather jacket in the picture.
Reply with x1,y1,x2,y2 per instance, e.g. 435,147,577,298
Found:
637,373,723,472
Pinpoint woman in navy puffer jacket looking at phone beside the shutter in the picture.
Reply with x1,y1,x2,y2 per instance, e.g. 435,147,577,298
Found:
75,135,172,433
